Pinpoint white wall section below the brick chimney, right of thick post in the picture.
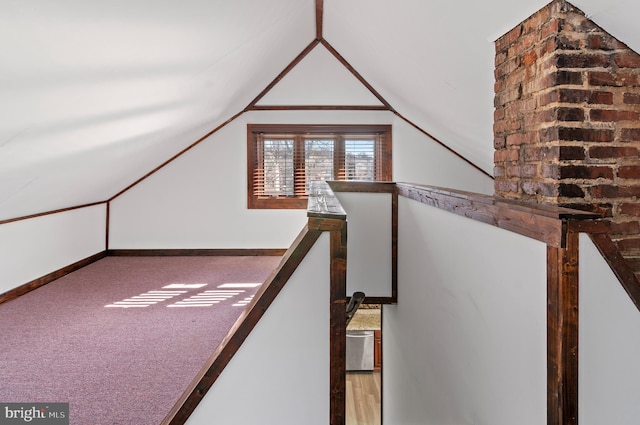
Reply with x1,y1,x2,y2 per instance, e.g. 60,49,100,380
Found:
578,235,640,425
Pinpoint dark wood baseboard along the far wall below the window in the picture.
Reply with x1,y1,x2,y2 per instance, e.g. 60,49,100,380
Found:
107,248,287,257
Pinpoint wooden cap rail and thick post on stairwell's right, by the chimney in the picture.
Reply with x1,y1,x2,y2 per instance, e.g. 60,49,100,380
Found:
397,183,608,425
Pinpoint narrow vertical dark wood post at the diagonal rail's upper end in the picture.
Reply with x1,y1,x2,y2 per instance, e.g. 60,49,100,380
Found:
329,221,347,425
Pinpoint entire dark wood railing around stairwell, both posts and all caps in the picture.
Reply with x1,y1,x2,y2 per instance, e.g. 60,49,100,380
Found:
163,182,640,425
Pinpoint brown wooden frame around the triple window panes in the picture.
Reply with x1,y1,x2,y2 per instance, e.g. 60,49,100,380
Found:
247,124,392,209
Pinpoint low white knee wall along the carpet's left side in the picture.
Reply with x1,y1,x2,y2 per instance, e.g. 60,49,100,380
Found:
0,205,106,293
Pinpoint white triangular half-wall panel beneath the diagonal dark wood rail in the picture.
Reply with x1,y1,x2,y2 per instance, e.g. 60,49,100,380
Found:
187,232,329,425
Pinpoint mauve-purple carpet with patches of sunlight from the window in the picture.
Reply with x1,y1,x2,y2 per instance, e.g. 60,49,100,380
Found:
0,257,280,425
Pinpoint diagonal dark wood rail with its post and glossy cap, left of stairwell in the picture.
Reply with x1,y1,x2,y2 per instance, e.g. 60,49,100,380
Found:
162,182,347,425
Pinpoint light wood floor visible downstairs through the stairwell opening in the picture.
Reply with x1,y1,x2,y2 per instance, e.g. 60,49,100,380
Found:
346,372,381,425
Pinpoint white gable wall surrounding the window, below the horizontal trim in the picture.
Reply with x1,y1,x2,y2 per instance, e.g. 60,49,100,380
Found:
109,111,493,249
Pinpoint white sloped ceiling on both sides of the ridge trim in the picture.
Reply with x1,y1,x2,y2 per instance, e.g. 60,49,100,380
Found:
0,0,640,220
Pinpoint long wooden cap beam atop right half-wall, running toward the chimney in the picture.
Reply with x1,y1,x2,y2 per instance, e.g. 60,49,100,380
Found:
396,183,600,247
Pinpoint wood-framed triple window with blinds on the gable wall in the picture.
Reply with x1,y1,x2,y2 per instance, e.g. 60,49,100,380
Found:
247,124,392,208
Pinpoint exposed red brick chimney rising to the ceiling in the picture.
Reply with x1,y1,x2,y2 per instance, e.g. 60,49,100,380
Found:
494,0,640,272
